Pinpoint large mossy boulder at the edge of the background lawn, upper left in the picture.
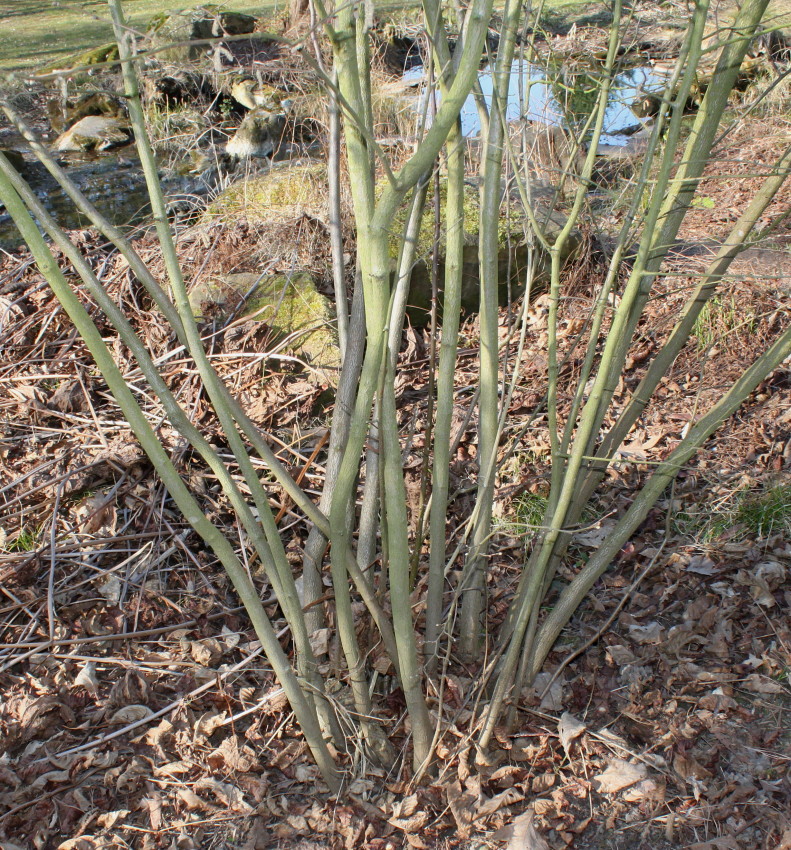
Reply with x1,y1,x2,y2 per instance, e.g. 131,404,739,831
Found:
146,5,256,62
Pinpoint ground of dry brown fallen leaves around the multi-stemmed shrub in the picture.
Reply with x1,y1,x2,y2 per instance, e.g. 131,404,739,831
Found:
0,1,791,850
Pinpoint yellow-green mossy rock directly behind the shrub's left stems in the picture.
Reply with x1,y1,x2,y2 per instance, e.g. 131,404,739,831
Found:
189,272,340,386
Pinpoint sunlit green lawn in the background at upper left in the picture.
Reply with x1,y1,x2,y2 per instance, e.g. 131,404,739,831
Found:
0,0,278,71
